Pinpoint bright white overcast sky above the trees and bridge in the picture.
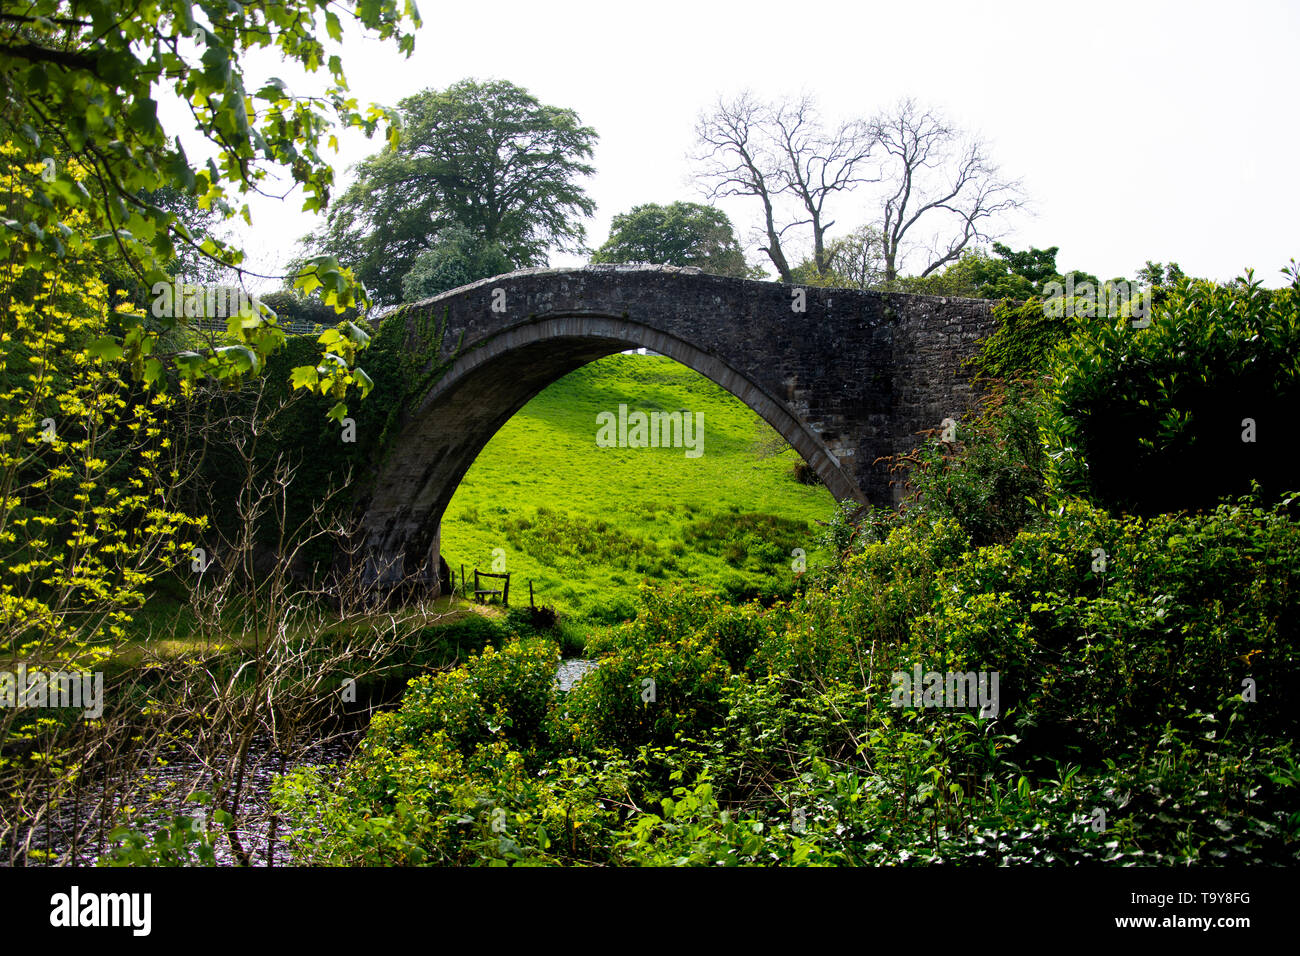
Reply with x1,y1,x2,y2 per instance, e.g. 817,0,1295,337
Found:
205,0,1300,291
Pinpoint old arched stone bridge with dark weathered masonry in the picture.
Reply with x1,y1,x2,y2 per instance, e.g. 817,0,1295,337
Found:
363,265,995,587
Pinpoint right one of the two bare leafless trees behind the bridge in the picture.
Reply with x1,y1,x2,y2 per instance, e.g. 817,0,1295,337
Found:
871,99,1024,282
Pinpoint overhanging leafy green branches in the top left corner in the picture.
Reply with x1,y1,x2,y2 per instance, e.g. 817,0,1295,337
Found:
0,0,420,416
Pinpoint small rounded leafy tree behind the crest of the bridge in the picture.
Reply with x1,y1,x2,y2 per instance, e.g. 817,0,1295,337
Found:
592,202,751,278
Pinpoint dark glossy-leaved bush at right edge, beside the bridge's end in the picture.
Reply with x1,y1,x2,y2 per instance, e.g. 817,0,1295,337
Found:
1049,264,1300,514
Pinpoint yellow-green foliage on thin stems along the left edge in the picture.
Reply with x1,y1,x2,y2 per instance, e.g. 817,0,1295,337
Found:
0,148,202,667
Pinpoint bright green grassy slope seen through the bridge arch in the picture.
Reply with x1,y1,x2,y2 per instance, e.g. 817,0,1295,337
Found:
442,355,835,622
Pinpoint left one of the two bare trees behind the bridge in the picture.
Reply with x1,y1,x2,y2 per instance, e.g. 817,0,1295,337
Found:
696,92,871,282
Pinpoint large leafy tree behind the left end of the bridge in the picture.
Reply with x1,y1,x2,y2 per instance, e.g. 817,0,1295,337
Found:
307,79,597,304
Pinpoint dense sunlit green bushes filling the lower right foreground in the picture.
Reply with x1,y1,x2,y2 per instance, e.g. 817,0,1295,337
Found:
271,489,1300,864
